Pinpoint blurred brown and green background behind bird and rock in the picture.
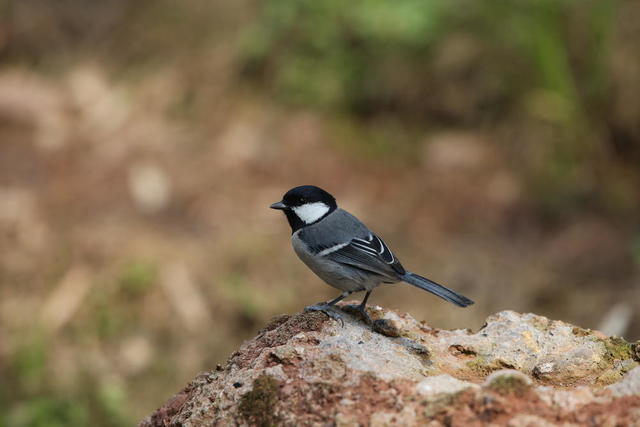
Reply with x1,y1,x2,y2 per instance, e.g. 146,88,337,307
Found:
0,0,640,426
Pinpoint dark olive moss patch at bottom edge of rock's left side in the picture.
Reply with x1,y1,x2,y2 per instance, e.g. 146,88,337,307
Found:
238,374,280,427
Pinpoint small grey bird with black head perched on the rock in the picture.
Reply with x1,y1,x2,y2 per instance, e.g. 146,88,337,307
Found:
270,185,474,323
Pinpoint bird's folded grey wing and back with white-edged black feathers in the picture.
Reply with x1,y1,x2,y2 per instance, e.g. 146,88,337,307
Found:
301,209,405,282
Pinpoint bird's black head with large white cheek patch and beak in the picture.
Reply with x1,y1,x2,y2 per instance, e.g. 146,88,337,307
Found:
271,185,338,232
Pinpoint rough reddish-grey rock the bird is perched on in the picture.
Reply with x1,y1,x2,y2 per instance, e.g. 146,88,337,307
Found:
140,307,640,427
